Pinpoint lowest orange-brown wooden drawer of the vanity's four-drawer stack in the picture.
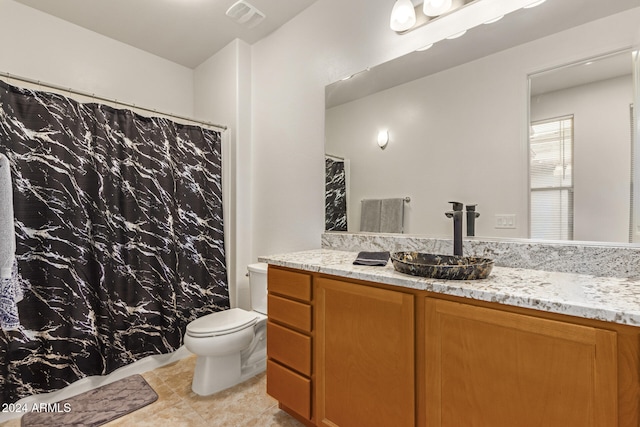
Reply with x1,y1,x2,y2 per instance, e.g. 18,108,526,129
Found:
267,360,311,419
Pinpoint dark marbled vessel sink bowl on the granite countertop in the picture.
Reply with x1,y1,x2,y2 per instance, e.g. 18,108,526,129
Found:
391,252,493,280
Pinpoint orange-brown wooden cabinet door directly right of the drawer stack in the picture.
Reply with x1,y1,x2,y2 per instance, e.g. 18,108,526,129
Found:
315,278,415,427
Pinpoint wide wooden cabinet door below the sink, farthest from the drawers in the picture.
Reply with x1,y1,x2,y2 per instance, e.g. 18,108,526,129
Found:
425,298,618,427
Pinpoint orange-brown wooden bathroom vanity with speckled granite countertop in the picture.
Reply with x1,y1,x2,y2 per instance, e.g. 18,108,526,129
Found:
260,249,640,427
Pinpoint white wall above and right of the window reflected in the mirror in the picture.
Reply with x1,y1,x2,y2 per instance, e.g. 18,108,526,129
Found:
531,75,633,242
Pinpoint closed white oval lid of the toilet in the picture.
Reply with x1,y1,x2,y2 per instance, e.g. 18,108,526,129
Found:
187,308,258,337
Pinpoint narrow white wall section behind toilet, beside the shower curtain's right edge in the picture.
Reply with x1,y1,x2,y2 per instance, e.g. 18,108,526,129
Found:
194,39,255,309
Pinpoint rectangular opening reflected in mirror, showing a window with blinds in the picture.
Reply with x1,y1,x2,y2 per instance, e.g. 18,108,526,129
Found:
529,51,634,242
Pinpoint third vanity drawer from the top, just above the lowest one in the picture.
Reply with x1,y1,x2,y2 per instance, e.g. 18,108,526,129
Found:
267,322,311,376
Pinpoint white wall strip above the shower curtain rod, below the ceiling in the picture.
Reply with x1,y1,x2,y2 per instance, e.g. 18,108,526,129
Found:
0,0,193,117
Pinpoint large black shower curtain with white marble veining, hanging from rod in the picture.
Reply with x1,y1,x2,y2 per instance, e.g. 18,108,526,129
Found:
0,81,229,402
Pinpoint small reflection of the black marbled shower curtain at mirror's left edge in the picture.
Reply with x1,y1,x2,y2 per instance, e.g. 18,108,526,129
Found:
324,157,347,231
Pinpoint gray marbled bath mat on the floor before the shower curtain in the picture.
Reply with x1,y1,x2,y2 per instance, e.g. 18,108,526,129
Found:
22,375,158,427
